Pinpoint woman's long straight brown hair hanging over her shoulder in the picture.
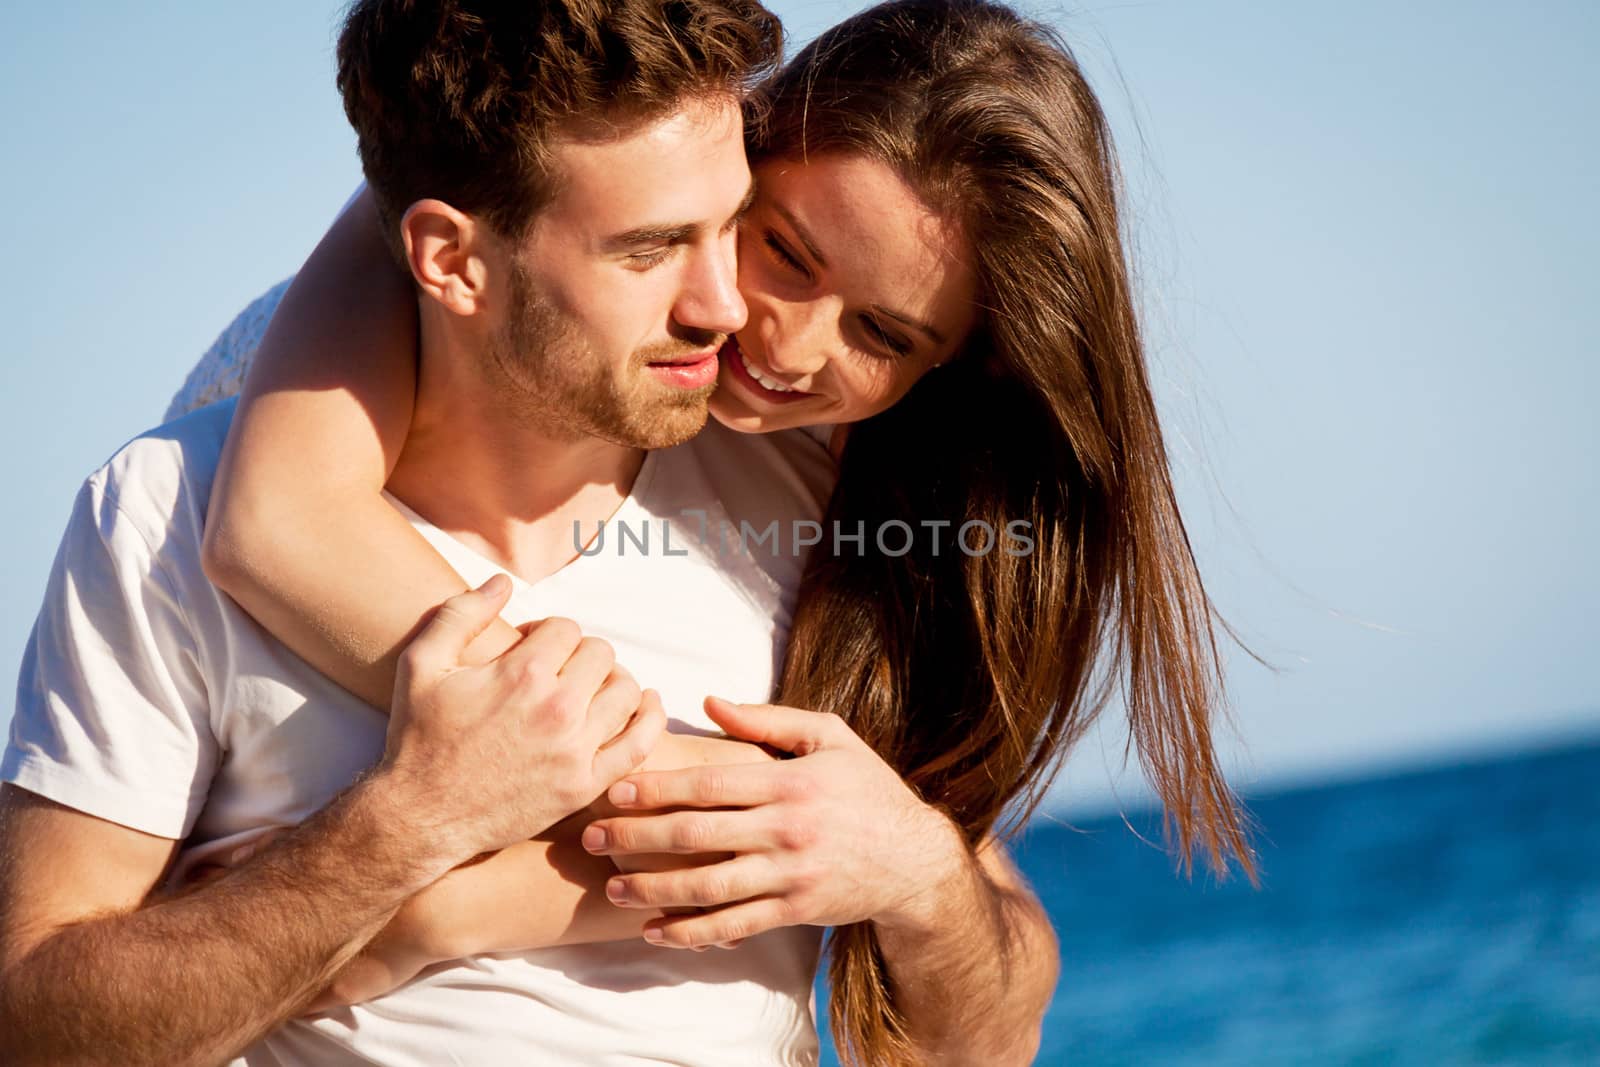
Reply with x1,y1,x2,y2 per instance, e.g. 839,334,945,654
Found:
752,0,1254,1067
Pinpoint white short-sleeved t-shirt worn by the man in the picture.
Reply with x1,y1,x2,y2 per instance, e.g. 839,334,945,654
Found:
0,402,834,1067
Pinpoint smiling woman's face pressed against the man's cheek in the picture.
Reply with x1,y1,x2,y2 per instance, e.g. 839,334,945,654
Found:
710,155,976,434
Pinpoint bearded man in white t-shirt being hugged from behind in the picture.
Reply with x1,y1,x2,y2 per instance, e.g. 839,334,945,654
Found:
0,2,1056,1064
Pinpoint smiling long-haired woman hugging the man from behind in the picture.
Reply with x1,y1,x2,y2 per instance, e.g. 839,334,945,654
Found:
181,0,1254,1064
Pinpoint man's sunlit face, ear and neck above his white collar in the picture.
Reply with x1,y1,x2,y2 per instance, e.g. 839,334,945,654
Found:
387,93,754,581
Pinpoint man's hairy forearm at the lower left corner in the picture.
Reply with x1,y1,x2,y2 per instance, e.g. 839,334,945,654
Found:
0,779,450,1065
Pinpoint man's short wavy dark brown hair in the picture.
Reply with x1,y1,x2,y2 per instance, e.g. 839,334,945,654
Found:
338,0,782,252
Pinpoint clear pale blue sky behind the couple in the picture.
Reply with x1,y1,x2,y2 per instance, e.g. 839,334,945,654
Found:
0,0,1600,803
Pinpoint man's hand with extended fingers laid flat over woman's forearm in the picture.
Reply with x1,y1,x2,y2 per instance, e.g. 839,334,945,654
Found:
584,697,966,949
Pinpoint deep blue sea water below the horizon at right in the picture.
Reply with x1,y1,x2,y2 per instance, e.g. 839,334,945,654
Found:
818,742,1600,1067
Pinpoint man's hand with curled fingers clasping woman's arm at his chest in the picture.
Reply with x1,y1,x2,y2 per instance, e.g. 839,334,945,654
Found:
370,574,666,873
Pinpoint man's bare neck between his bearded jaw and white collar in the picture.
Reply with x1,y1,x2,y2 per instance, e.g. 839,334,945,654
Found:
389,301,645,582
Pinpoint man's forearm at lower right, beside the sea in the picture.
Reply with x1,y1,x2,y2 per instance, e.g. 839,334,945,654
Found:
874,824,1059,1065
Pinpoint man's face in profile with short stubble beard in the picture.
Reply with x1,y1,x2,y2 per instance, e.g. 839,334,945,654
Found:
488,94,750,448
